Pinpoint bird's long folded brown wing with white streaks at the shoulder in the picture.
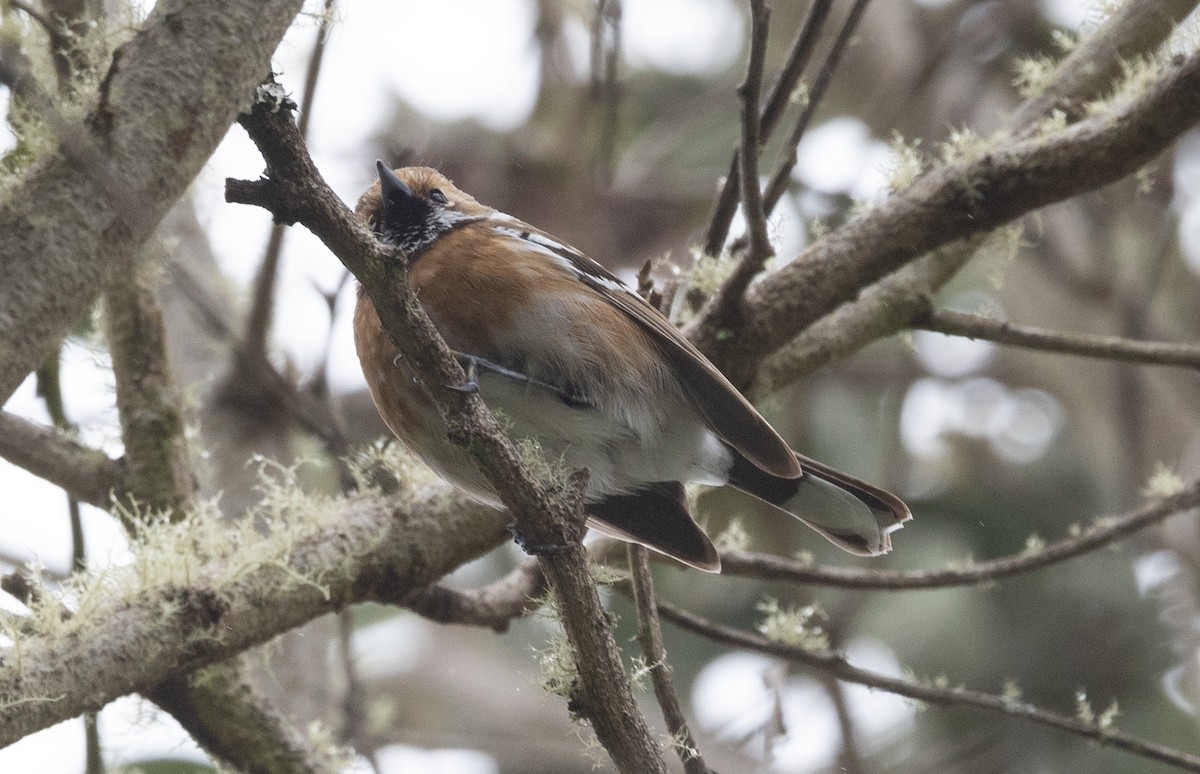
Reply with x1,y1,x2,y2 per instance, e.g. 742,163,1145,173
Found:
496,220,800,478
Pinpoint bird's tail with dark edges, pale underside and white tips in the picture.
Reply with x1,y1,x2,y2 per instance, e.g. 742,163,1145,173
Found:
730,452,912,557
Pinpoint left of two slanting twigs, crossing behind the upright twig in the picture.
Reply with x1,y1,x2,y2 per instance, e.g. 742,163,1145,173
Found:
703,0,833,256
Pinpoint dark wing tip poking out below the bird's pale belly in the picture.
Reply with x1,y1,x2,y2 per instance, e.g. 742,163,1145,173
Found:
587,481,721,572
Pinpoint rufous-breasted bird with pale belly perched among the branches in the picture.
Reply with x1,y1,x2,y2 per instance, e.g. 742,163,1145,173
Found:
354,162,911,572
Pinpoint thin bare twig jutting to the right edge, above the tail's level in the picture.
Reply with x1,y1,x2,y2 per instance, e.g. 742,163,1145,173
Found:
913,310,1200,368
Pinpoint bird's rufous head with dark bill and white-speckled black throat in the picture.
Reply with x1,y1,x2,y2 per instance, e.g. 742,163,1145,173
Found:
354,161,494,256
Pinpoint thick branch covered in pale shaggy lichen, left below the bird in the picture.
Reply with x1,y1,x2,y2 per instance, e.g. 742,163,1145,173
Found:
0,491,508,746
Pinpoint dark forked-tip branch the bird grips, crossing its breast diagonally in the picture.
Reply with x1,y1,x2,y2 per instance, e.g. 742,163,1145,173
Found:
226,88,664,772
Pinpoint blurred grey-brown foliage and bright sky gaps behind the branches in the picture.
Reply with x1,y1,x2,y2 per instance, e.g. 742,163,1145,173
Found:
7,0,1200,773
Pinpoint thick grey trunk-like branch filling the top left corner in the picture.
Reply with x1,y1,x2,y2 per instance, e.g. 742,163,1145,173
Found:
0,0,304,403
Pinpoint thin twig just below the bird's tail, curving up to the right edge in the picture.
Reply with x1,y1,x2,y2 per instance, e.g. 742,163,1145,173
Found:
721,480,1200,590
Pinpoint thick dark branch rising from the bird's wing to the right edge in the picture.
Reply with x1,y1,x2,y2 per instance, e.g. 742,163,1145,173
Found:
689,42,1200,384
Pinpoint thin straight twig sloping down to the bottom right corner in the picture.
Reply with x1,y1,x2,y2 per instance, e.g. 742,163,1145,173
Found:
659,601,1200,772
